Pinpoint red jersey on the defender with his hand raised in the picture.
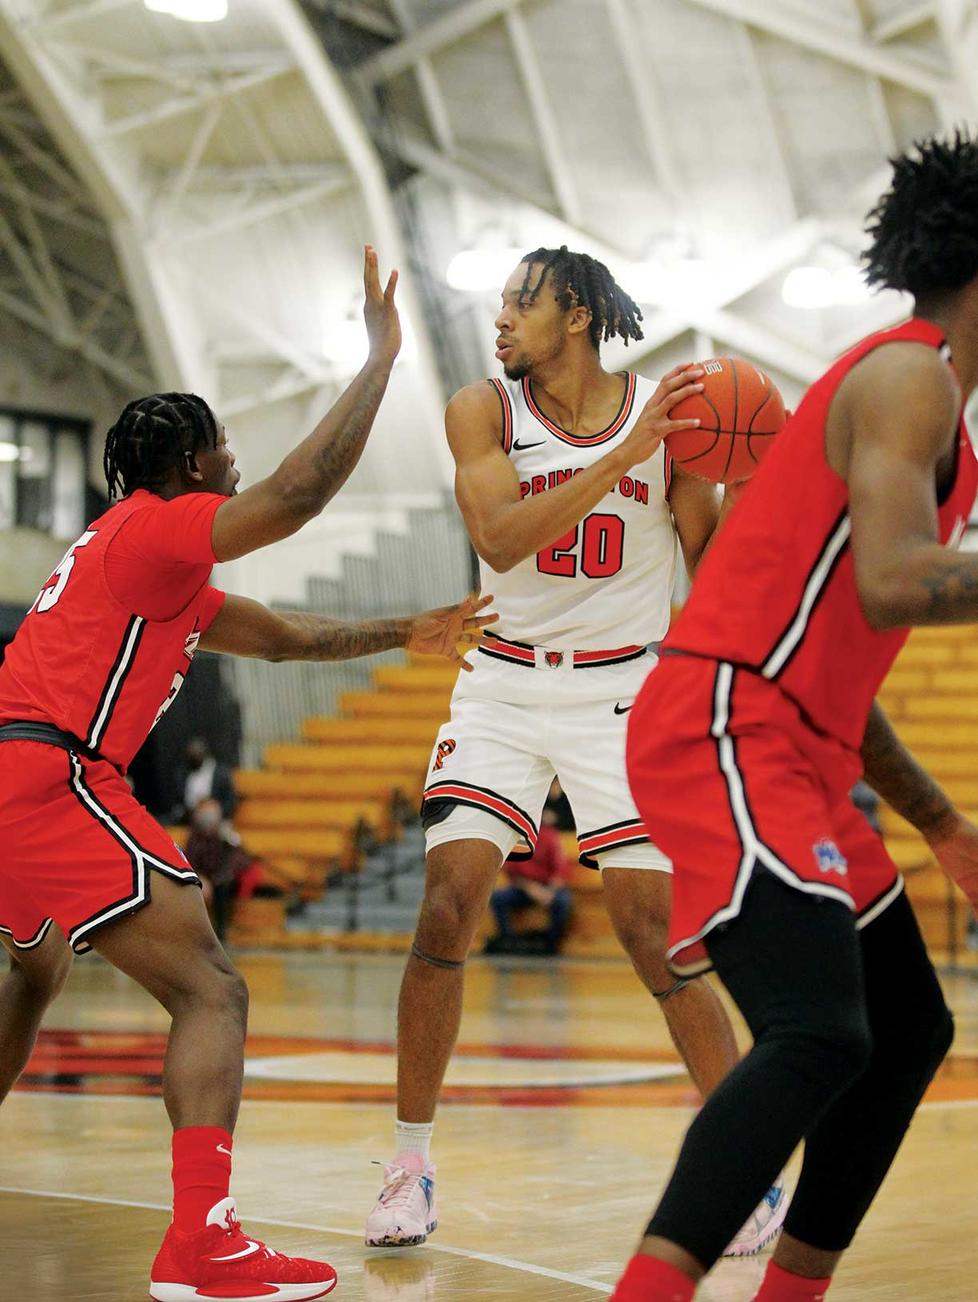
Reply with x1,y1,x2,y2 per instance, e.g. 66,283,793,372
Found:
0,490,225,769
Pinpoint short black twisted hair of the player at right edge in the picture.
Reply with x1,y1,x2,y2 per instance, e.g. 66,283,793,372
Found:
863,128,978,298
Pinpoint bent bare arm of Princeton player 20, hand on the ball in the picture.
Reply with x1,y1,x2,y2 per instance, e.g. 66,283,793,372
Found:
445,367,702,574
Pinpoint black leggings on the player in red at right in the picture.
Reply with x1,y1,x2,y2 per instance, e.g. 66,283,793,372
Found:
647,870,953,1269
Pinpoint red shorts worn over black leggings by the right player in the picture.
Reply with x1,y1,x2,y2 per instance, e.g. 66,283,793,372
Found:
628,655,902,977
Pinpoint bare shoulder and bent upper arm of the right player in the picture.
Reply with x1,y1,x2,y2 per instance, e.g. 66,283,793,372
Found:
830,344,978,630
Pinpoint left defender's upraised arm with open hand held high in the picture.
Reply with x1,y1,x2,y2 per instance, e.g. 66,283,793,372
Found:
212,246,401,561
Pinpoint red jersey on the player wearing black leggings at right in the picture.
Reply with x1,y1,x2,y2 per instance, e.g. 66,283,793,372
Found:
665,319,978,749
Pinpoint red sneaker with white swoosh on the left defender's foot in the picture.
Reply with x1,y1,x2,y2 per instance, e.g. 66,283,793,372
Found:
150,1198,336,1302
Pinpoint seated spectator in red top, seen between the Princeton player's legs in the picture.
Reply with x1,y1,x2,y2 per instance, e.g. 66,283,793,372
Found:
486,805,573,954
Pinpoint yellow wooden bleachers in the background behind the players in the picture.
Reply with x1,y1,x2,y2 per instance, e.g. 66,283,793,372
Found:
188,628,978,954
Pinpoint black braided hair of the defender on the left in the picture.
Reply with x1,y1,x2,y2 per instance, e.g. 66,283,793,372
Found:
102,393,217,497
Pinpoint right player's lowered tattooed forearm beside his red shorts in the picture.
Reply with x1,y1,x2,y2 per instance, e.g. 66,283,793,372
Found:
862,702,978,910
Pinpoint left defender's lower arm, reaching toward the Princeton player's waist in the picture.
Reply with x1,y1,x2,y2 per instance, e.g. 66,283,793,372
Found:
201,595,496,669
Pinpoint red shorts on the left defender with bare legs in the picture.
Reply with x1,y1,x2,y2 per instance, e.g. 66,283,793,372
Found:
0,741,199,953
